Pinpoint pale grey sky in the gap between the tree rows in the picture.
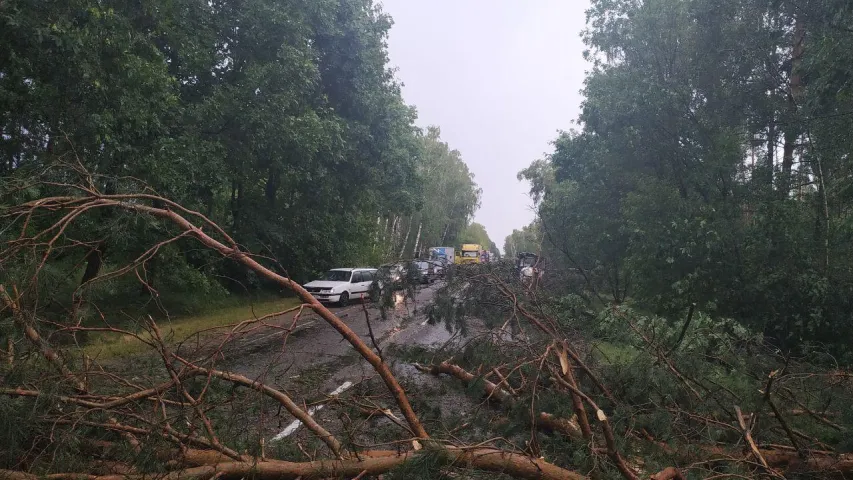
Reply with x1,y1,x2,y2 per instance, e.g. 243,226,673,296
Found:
381,0,589,248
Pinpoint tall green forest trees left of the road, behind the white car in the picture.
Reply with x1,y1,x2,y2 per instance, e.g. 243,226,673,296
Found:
0,0,489,311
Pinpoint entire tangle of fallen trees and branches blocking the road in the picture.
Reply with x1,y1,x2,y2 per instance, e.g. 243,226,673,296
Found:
0,169,853,480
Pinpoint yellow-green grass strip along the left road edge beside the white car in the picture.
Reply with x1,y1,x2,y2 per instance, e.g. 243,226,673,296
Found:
83,297,301,360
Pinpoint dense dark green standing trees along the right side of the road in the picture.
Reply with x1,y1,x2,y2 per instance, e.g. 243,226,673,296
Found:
519,0,853,361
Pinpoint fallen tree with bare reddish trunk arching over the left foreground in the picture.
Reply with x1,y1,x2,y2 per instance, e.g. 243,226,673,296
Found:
0,169,596,479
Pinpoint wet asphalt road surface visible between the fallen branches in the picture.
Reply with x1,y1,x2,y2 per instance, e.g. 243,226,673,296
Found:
187,283,470,442
